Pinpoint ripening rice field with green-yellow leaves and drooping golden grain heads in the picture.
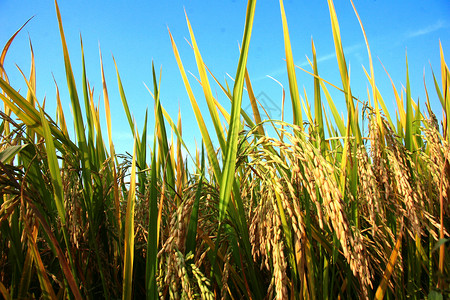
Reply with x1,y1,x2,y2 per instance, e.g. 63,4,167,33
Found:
0,0,450,299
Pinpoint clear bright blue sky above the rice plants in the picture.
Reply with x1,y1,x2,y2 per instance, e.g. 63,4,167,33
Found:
0,0,450,157
